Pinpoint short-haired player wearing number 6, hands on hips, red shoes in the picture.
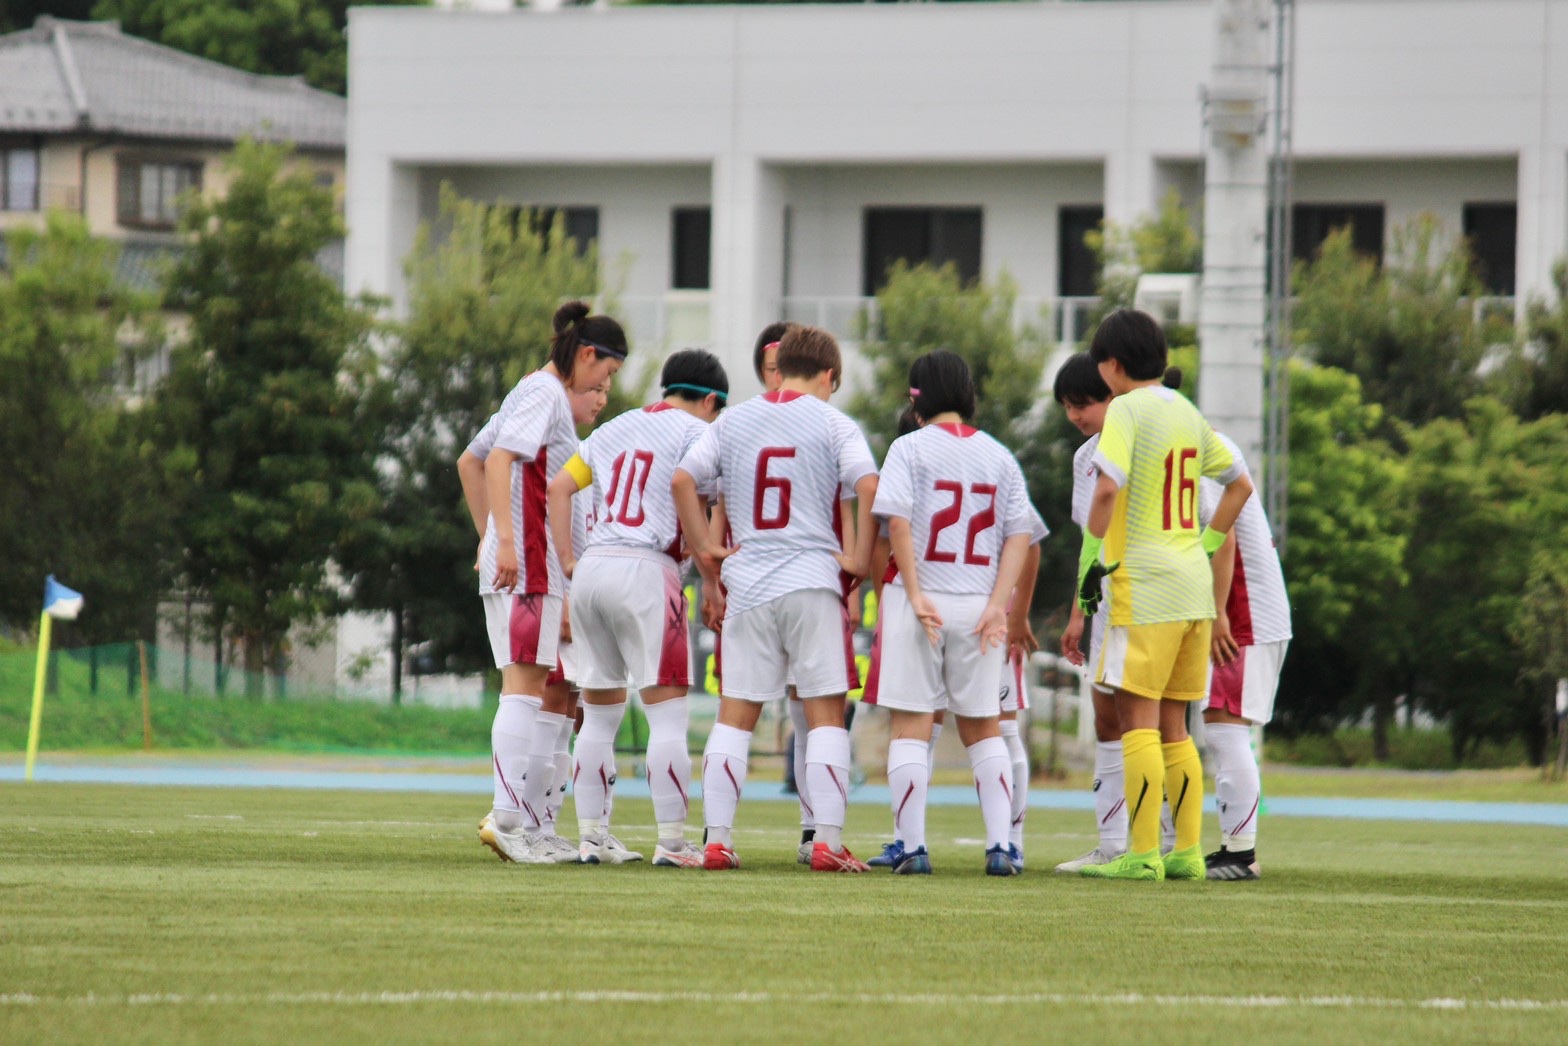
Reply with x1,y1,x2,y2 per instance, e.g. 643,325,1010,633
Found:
673,328,877,872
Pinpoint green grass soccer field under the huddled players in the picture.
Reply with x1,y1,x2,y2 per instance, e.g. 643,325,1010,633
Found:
0,784,1568,1043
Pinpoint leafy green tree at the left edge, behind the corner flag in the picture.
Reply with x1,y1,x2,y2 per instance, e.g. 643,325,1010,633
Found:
0,212,169,641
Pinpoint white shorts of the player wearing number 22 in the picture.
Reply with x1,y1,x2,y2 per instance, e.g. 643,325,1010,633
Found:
877,585,1007,718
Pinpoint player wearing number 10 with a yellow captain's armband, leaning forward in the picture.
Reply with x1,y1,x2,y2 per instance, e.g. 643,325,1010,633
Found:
550,348,729,867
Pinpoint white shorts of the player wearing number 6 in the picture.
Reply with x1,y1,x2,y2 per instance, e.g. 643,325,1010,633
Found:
723,588,855,701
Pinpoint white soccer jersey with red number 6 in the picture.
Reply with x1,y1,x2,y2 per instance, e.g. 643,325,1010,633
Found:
681,390,877,615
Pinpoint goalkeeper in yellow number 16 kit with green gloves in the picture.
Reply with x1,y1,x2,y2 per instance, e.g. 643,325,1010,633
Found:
1079,309,1253,880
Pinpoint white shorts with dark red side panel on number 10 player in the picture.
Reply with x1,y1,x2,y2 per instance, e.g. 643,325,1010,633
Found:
572,546,691,690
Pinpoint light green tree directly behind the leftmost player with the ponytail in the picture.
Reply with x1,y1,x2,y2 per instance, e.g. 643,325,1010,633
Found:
351,187,611,686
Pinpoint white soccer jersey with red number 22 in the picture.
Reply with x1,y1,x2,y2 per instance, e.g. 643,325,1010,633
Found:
872,423,1036,596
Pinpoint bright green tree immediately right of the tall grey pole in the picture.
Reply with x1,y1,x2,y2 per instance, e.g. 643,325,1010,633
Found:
1279,361,1410,757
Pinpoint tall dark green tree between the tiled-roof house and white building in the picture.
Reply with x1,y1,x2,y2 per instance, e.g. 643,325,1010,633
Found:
157,141,379,693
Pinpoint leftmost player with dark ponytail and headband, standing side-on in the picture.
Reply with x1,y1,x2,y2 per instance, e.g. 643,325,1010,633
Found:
480,301,627,864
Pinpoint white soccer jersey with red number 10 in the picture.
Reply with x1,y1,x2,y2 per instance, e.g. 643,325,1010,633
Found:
577,403,707,560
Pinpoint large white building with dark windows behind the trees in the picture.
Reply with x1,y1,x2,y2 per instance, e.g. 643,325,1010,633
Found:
347,0,1568,392
